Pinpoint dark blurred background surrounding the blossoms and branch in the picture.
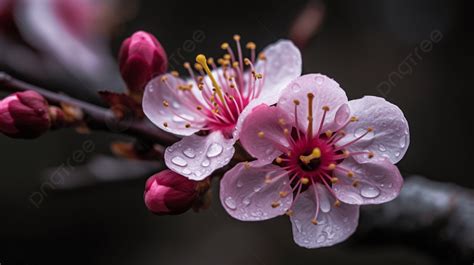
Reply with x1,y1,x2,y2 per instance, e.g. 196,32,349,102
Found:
0,0,474,265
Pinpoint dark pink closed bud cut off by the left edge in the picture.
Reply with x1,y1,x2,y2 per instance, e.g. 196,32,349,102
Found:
0,91,51,139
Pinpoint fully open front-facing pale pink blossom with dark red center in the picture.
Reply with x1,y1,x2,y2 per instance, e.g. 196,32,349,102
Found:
220,74,409,248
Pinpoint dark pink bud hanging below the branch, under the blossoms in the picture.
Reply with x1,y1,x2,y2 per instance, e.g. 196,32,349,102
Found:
144,169,199,215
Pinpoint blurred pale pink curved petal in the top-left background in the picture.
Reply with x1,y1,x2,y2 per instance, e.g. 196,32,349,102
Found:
15,0,108,79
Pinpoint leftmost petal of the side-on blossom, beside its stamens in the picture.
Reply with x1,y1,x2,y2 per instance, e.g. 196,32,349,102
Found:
143,74,205,136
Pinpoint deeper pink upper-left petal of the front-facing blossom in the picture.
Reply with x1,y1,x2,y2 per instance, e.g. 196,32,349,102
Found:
240,104,293,163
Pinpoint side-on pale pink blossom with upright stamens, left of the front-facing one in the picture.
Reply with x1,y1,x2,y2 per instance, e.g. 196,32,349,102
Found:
143,35,301,180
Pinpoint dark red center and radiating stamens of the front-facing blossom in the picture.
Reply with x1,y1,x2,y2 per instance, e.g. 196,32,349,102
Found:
267,90,374,224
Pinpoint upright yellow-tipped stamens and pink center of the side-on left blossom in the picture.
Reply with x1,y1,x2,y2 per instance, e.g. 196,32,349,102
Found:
163,35,266,136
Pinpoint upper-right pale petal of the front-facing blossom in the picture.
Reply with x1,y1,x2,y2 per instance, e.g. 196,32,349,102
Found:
339,96,410,163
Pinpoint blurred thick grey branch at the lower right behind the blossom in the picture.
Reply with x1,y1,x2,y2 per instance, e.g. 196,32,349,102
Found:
357,176,474,264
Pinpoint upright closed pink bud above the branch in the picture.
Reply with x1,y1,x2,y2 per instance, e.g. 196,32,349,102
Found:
119,31,168,92
